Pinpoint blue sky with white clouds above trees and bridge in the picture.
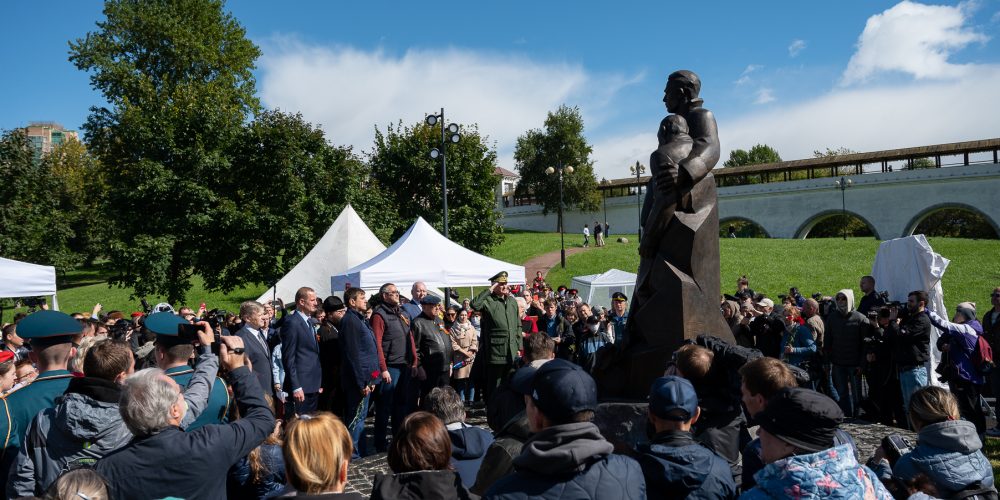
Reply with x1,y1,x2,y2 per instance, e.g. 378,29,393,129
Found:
0,0,1000,178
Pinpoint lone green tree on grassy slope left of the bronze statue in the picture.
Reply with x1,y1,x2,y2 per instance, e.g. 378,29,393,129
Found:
514,105,601,230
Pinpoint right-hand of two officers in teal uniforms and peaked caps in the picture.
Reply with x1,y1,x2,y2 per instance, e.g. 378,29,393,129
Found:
146,312,229,432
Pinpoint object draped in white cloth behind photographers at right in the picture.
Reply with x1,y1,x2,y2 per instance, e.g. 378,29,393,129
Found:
872,234,951,385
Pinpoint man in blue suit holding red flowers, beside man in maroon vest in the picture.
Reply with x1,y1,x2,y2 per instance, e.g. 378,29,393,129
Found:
338,288,381,459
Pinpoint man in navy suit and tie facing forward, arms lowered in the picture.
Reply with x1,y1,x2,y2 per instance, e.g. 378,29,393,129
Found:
281,287,323,415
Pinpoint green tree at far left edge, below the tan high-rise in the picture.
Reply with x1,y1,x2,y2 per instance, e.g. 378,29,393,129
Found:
0,129,80,270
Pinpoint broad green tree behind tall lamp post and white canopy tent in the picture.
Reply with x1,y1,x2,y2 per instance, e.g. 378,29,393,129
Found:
368,122,503,253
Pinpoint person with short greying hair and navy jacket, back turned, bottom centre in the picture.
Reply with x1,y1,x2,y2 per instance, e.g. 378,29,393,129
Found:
425,386,493,488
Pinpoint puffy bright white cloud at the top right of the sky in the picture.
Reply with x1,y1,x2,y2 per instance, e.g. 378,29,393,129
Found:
841,0,989,85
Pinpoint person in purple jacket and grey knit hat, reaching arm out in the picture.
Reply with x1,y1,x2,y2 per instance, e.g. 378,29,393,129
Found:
926,302,986,436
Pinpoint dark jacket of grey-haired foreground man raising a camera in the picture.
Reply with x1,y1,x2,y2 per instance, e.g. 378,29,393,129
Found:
96,366,274,500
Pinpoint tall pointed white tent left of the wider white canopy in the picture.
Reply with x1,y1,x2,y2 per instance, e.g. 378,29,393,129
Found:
257,205,385,305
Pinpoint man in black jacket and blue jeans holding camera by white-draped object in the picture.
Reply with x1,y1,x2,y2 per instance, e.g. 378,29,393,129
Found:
889,290,931,424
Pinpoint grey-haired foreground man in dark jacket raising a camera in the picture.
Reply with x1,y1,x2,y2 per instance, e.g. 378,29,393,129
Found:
96,336,274,499
